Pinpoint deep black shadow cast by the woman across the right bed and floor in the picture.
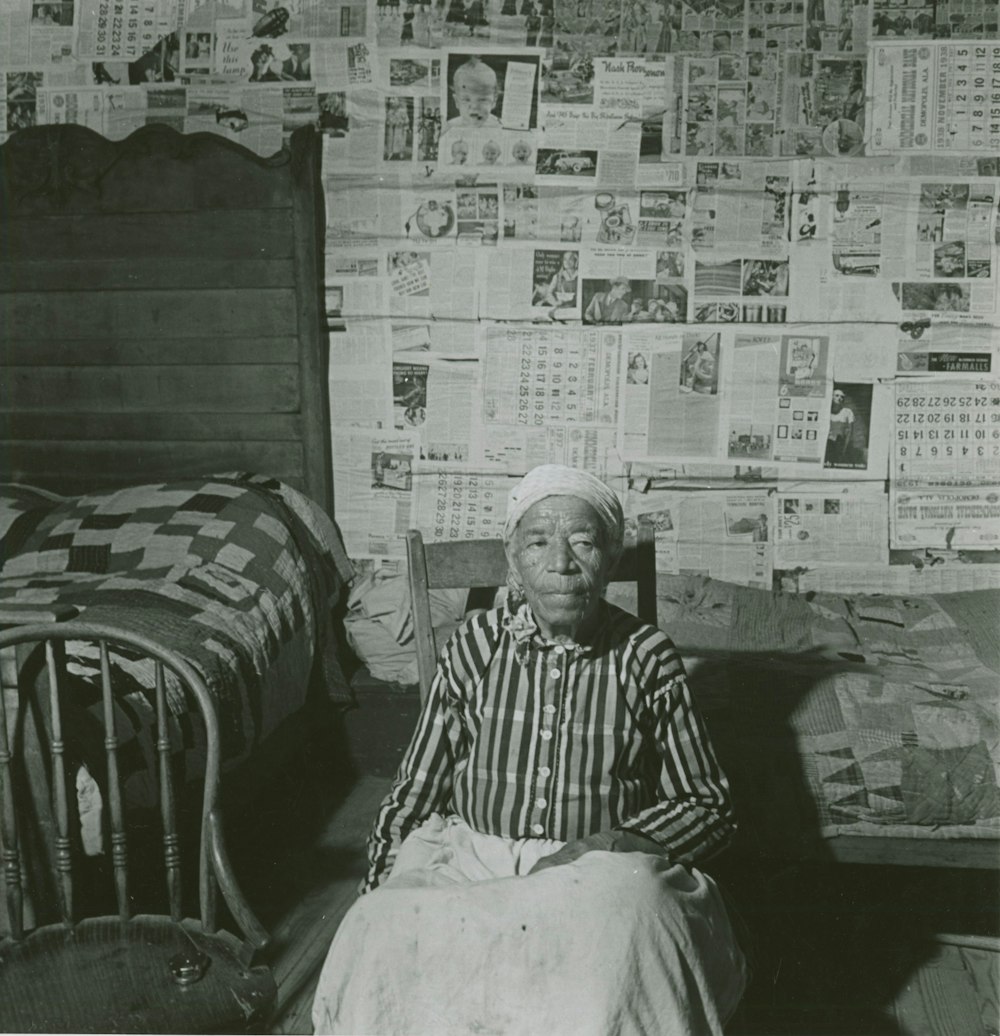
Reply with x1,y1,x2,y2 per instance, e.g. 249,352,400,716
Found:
688,652,1000,1036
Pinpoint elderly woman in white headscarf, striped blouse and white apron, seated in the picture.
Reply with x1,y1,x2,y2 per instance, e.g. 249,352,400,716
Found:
313,465,745,1036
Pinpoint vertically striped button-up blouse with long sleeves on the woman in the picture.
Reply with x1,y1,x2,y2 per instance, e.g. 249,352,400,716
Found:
362,601,734,891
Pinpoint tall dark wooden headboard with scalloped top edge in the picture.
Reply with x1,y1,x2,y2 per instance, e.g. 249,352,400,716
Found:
0,124,333,514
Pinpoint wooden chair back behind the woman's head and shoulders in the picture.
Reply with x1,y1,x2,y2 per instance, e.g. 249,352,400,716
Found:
406,516,657,700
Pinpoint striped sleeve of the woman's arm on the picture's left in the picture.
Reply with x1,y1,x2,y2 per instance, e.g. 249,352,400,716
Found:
361,634,467,894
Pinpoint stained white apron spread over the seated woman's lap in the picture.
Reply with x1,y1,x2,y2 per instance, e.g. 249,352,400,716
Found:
313,816,745,1036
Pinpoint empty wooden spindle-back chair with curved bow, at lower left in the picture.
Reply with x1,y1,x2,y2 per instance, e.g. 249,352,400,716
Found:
0,615,277,1033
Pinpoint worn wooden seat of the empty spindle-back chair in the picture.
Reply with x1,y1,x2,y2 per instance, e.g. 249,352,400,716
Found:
0,916,277,1033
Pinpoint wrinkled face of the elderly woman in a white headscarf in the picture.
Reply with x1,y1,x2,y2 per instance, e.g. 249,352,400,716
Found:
507,496,612,639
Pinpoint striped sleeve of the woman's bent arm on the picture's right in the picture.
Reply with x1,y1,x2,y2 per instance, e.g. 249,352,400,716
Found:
617,638,736,863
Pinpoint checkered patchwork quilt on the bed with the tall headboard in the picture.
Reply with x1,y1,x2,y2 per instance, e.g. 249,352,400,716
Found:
0,472,351,792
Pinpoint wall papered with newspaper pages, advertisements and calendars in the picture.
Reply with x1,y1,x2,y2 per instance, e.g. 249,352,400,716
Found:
9,0,1000,592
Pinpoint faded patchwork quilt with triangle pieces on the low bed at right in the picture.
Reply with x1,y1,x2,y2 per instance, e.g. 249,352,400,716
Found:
609,576,1000,848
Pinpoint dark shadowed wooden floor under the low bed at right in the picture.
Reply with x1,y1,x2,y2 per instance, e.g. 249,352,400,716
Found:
719,861,1000,1036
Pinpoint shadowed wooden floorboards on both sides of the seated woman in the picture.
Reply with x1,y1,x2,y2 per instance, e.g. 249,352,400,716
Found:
227,704,1000,1036
